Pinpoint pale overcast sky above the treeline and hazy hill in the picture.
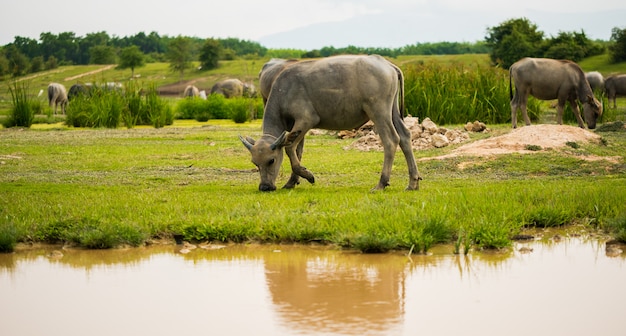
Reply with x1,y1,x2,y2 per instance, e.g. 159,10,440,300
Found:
0,0,626,49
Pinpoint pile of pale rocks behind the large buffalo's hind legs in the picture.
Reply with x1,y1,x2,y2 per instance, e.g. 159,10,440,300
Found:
338,117,469,151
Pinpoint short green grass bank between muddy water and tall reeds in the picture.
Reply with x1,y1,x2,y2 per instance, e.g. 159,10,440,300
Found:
0,120,626,252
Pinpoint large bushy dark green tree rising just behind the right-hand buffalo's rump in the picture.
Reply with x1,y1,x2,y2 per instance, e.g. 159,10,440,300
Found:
485,18,543,69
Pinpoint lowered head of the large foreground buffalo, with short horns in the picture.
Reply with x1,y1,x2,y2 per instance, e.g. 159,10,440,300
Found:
239,132,287,191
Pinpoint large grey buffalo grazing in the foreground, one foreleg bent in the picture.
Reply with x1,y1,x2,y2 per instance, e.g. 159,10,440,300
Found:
239,55,421,191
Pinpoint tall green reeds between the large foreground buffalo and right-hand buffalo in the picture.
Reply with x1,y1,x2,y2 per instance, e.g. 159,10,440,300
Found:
404,62,540,125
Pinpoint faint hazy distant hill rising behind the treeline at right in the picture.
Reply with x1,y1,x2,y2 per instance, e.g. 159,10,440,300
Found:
259,8,626,50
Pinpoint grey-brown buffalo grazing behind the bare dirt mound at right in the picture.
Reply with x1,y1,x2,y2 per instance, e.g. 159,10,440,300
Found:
509,58,602,129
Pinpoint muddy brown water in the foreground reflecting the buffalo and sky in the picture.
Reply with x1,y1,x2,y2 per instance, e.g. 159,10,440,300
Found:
0,238,626,336
